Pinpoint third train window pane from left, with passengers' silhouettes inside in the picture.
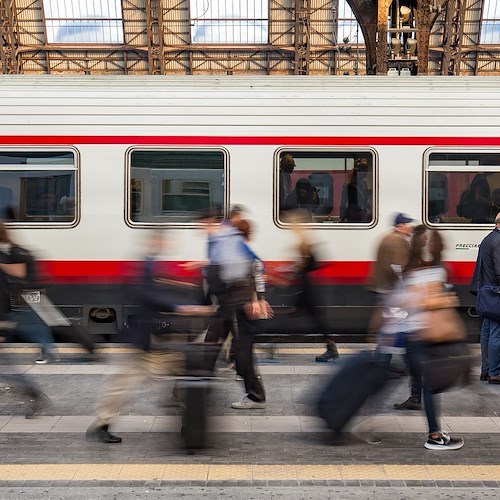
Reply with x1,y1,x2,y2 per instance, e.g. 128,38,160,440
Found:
276,150,375,225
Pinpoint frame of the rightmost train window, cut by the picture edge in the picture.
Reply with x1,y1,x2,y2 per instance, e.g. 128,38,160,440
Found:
422,147,500,231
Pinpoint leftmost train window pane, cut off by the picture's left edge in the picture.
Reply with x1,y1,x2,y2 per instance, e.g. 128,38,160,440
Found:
0,150,77,223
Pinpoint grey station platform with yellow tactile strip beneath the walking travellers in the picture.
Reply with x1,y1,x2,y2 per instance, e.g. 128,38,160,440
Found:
0,344,500,499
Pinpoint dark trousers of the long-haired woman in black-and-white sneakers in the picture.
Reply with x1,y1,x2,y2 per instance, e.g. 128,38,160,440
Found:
406,339,439,434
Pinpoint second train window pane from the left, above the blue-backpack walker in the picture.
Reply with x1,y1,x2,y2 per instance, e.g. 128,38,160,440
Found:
128,149,226,224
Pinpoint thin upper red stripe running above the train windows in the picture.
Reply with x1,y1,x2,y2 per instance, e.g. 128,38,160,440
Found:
0,135,500,146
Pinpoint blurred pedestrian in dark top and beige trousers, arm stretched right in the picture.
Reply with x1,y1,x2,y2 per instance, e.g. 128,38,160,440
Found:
86,232,213,443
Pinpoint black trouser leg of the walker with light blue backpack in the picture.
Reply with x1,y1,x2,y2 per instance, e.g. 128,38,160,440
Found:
234,308,266,402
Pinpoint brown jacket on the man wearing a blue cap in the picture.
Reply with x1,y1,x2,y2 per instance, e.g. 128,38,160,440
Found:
370,232,410,293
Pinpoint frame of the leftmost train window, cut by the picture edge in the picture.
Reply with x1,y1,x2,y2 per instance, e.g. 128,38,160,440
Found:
0,146,81,229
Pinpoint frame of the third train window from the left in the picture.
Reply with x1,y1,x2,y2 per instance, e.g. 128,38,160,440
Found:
273,146,379,230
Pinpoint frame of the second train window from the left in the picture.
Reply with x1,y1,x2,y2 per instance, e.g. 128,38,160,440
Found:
124,145,230,229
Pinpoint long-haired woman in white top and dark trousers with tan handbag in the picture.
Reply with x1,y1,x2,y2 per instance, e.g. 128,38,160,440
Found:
393,226,465,450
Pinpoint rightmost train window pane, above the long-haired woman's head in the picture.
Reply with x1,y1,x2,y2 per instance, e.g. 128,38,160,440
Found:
425,151,500,226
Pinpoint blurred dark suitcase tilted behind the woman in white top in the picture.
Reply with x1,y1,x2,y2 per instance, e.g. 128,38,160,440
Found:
317,352,387,433
